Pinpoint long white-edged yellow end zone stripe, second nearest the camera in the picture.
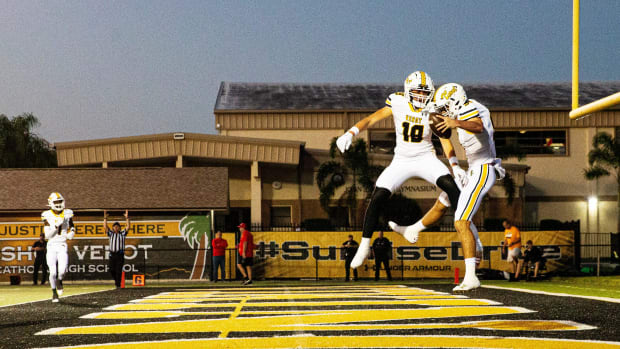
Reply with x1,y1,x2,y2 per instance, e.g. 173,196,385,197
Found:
39,304,532,335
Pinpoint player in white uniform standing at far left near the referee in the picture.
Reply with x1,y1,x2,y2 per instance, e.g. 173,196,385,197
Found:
41,193,75,303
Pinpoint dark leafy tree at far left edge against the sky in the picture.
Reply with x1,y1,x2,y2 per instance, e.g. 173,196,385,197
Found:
0,113,57,168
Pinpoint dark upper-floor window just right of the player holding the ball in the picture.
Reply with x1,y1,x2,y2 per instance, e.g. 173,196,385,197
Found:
494,130,567,157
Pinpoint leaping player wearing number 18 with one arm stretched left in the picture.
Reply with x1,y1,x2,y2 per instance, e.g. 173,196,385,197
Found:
336,71,459,268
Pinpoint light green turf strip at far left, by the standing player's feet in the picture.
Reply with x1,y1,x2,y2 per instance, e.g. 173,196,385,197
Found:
0,284,114,307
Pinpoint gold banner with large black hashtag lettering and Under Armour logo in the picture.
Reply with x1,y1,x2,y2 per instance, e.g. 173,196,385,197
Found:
254,231,574,278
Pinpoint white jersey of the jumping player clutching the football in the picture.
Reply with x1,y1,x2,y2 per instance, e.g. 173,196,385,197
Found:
457,99,495,167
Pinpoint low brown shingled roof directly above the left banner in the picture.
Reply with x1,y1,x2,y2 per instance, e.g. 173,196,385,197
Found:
0,167,228,212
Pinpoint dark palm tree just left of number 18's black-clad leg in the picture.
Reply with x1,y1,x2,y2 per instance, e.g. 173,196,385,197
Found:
316,138,383,227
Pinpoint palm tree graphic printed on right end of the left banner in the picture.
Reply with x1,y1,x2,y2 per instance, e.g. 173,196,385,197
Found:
179,213,211,280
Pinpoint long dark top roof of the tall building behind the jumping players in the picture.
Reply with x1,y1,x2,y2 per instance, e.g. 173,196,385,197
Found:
215,81,620,112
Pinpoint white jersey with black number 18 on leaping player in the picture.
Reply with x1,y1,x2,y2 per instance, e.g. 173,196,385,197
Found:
385,92,435,157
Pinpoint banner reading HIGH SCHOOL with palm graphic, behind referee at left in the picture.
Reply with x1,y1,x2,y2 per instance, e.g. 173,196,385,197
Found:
0,214,218,282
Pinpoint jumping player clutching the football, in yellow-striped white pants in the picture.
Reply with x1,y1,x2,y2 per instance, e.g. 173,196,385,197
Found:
398,83,506,291
